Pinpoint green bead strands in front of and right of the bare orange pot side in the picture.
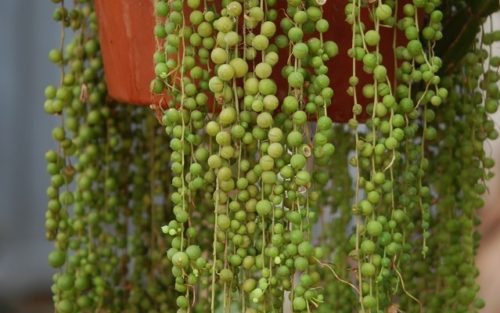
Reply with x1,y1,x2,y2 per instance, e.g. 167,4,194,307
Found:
151,0,498,312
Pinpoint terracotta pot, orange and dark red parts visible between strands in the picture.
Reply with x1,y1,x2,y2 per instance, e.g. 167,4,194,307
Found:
95,0,411,122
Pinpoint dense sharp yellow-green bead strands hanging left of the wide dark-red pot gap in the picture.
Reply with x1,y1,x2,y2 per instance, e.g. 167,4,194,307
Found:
152,1,338,312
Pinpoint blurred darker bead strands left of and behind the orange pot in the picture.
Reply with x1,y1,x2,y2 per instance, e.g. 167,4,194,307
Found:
44,0,175,313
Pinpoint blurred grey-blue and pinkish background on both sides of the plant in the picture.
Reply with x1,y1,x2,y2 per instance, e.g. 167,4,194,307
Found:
0,0,500,313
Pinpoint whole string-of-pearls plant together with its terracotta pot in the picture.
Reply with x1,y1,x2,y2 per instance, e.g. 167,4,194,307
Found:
45,0,500,313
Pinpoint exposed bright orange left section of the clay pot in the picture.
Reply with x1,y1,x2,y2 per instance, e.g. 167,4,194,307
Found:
94,0,156,105
